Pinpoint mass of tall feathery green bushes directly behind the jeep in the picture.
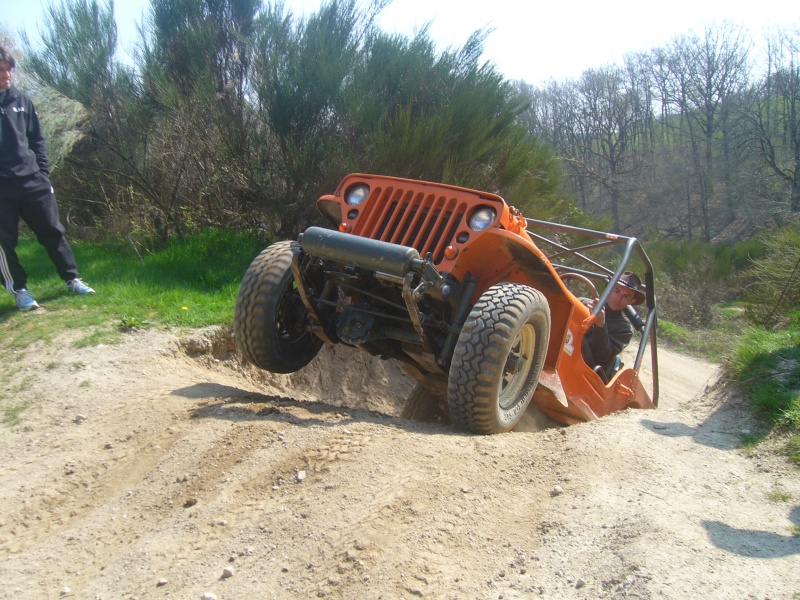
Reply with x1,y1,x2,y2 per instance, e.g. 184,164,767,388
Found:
15,0,568,239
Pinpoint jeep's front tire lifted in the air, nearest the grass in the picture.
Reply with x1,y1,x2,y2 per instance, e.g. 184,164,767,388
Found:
234,241,322,373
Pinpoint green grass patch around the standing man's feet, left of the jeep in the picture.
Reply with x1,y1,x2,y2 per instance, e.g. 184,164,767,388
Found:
0,231,267,348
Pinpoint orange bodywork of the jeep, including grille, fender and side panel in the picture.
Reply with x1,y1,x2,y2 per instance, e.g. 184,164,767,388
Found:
318,174,655,424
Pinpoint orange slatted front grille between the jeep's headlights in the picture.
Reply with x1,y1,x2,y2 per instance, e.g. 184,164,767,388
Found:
353,187,468,264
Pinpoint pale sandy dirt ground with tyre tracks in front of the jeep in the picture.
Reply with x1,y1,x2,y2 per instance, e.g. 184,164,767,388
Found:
0,331,800,600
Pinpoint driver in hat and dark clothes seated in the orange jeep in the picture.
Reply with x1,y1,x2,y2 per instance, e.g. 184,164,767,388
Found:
581,271,645,381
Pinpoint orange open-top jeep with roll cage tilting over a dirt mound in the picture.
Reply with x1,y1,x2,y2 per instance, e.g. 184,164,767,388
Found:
234,174,658,434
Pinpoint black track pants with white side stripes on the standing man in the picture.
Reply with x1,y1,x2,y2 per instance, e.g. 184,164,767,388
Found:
0,174,78,294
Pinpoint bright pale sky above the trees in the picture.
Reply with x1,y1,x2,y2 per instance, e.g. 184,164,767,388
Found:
0,0,800,85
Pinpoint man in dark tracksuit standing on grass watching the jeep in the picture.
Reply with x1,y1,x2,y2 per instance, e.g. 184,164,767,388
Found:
0,46,94,310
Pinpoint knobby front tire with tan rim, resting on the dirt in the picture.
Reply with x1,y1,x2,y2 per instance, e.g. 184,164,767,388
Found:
447,283,550,434
